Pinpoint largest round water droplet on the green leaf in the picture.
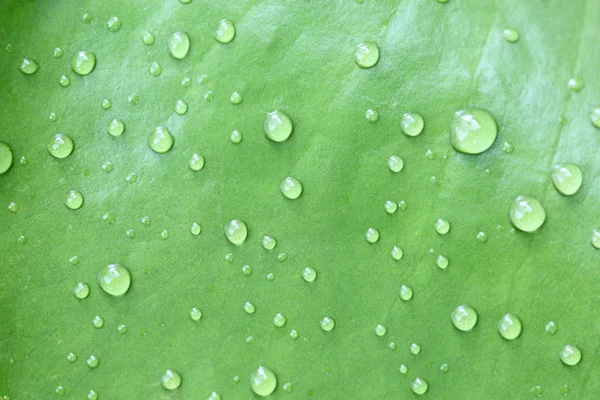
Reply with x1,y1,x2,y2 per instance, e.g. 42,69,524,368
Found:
450,108,498,154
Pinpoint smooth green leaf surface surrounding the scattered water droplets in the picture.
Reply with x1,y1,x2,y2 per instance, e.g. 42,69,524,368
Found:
0,0,600,399
